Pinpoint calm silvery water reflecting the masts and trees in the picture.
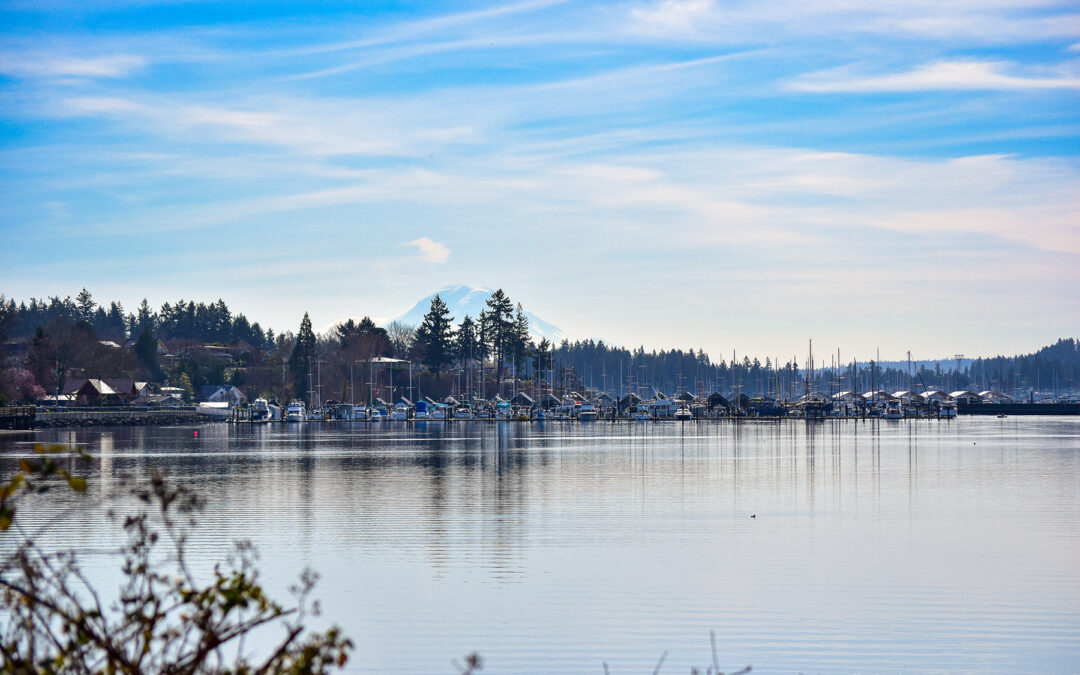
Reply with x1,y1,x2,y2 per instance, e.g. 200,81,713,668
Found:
0,418,1080,674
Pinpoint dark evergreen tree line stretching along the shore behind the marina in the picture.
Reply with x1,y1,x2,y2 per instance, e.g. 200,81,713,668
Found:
0,288,1080,401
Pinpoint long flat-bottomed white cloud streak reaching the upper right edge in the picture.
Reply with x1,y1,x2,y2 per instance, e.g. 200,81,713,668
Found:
791,60,1080,93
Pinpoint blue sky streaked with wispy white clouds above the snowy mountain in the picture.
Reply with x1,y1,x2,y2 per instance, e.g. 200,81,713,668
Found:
0,0,1080,359
